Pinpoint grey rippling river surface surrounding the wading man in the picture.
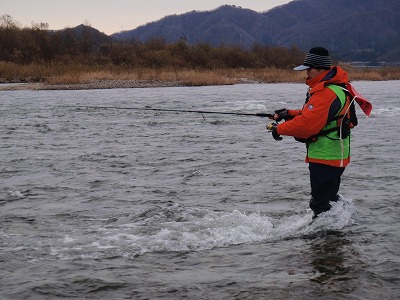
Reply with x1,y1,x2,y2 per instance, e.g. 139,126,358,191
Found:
0,81,400,299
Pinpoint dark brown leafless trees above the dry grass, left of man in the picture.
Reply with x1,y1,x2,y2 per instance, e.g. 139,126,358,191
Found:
0,15,304,69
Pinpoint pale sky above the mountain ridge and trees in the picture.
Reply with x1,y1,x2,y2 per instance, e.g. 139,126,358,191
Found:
0,0,292,34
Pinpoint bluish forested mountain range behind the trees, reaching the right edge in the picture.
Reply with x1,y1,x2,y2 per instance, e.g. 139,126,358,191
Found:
111,0,400,61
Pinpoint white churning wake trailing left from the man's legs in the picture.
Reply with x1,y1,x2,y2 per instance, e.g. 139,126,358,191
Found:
52,198,355,259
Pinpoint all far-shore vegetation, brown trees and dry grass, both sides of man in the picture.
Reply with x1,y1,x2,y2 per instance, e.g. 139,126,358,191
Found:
0,15,400,90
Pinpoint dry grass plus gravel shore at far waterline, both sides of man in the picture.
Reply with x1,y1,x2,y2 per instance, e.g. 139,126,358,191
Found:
0,62,400,91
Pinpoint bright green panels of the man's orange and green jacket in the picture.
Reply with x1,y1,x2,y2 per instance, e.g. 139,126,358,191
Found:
307,85,350,160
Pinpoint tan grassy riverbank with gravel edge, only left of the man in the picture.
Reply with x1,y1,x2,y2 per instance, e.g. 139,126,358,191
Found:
0,68,296,90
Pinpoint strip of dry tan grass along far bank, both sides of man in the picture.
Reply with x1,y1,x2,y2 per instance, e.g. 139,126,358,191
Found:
0,62,400,86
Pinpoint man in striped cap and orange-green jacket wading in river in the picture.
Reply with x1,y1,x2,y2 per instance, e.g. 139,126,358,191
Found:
267,47,357,218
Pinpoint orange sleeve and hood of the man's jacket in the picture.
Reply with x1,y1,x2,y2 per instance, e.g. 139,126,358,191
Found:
277,67,349,139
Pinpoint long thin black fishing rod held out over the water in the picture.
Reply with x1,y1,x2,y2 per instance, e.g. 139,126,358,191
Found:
62,105,274,119
